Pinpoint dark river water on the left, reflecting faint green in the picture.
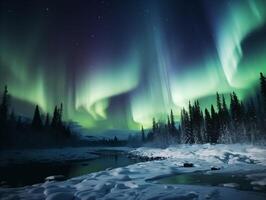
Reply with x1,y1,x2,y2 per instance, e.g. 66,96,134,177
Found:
0,150,138,187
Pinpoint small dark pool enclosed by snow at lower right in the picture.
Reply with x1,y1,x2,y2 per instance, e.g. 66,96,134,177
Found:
155,172,266,192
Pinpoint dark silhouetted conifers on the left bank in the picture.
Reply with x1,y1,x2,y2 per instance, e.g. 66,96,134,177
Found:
0,86,72,147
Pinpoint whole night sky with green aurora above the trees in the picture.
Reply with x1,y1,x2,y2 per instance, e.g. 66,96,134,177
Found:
0,0,266,129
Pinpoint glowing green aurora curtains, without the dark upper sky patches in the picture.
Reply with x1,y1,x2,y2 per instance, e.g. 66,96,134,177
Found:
0,0,266,129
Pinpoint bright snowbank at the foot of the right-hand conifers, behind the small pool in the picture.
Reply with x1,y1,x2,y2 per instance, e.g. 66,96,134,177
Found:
130,144,266,170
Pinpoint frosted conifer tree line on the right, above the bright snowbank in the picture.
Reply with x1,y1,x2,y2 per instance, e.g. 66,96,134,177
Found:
141,73,266,145
